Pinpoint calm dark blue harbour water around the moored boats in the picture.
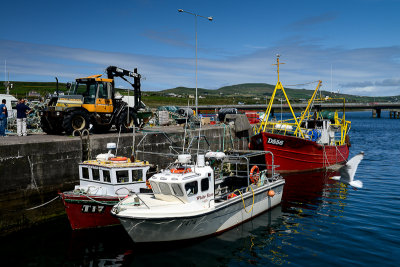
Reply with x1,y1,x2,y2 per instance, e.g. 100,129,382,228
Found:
0,111,400,266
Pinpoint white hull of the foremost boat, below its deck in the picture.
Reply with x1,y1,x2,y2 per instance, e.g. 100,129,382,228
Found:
117,183,284,242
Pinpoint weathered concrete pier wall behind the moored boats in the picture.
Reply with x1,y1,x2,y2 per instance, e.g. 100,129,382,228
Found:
0,125,247,234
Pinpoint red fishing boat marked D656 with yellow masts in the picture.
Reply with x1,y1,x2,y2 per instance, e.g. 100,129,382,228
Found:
249,56,351,173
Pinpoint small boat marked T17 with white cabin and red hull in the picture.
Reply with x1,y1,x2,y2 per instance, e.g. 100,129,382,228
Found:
60,143,150,230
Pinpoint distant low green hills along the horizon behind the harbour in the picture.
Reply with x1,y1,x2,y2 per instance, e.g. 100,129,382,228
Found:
0,82,400,106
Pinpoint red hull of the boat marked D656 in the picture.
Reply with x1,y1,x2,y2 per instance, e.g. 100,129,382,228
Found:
250,132,349,173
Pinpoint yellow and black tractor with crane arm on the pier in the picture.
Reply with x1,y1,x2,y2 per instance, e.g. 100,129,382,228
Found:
40,66,152,134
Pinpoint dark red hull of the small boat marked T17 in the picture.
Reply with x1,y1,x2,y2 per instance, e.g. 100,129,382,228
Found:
60,192,120,230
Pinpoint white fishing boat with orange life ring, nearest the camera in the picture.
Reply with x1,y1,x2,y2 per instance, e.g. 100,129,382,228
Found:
111,151,285,242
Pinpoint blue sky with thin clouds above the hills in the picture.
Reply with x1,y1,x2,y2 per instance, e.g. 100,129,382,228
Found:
0,0,400,96
